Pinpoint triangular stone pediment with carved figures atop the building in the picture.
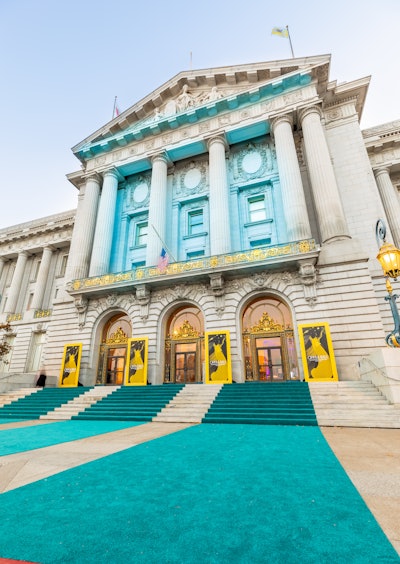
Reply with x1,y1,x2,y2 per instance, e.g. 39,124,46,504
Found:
72,55,330,158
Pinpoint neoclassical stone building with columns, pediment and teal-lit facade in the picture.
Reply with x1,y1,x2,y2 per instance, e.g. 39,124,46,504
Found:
0,55,400,385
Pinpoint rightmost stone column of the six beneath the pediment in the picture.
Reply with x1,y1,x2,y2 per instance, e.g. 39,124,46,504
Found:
299,106,350,243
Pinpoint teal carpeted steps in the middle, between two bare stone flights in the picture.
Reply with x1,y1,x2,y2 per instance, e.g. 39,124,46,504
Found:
72,384,183,421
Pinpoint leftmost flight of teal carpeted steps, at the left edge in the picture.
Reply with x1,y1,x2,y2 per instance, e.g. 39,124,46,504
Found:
0,386,90,419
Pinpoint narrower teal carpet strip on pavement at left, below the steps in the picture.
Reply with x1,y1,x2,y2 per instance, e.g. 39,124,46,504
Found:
0,421,140,456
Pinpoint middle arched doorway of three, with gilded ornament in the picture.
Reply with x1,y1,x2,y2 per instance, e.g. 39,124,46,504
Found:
164,306,204,384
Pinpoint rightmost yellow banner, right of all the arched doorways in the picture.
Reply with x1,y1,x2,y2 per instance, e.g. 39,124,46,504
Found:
298,323,338,382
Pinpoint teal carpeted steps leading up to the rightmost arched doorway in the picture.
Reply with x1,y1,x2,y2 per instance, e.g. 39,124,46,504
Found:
202,382,318,425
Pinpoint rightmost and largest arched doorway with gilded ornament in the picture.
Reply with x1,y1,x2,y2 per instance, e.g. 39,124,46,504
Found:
242,296,299,382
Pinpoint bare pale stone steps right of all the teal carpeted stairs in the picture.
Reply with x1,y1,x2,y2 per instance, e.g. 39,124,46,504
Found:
309,381,400,429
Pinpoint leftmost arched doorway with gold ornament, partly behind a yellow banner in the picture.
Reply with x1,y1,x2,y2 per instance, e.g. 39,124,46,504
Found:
96,313,132,386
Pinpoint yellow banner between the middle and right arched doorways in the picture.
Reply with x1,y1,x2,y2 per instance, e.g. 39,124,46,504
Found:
205,331,232,384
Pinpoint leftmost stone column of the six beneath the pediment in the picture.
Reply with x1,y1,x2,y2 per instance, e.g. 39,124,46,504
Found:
65,175,100,281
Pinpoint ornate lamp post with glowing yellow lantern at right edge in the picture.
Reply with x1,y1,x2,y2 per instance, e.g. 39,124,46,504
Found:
376,219,400,347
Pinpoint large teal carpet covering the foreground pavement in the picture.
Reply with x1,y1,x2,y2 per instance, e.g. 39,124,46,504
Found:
0,424,400,564
